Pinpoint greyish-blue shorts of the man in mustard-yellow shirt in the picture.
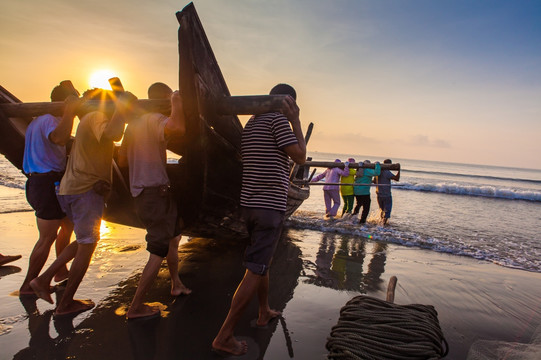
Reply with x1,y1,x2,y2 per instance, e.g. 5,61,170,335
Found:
58,190,105,244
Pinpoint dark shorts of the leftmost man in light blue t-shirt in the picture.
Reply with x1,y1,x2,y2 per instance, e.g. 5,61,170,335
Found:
26,172,66,220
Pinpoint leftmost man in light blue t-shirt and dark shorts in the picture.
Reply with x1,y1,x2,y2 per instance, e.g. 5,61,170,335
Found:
19,80,80,296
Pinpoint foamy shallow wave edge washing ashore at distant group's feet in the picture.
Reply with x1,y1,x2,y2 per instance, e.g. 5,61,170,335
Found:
286,211,541,272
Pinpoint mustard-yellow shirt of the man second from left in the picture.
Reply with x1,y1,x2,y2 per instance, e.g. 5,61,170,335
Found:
59,111,114,195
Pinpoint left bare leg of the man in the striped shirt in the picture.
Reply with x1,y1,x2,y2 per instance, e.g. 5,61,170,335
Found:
212,270,262,355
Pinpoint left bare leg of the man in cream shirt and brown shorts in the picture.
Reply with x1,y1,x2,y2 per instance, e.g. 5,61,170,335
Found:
126,254,163,319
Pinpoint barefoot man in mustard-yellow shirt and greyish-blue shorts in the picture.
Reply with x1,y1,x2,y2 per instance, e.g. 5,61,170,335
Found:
30,89,135,316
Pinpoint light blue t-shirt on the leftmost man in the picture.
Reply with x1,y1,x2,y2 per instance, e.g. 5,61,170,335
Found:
23,114,66,174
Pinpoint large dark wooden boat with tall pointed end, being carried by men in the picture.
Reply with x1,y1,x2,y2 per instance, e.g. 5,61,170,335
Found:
0,4,310,238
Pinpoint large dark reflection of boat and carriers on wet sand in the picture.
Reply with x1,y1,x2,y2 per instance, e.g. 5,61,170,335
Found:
11,236,302,360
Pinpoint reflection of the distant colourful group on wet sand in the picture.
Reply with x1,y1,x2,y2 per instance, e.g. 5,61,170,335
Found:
304,233,387,293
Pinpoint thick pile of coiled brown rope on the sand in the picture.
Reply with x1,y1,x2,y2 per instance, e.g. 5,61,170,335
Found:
326,295,449,360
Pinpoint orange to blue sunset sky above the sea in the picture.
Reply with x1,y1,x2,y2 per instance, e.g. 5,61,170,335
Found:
0,0,541,169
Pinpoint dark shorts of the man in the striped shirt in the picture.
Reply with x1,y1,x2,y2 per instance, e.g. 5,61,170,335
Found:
242,208,285,275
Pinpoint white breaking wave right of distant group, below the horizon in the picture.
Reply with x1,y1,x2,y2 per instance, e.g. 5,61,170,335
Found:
395,183,541,202
